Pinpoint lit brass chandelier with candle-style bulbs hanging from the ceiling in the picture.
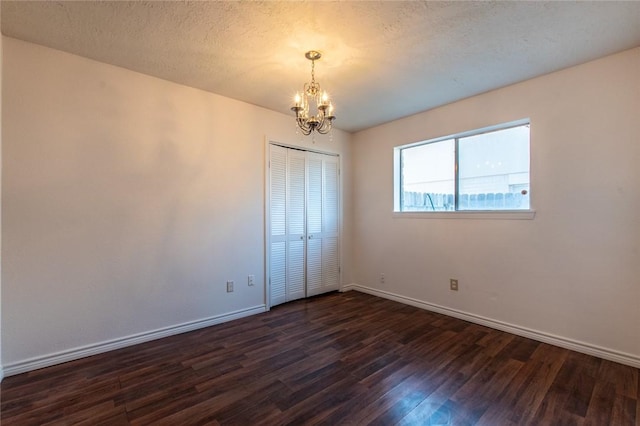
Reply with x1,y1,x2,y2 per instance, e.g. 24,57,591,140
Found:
291,50,336,136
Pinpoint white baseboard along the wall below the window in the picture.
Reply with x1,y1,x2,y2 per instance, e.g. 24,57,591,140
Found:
340,284,640,368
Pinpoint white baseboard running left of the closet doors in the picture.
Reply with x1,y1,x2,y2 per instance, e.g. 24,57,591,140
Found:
0,305,266,377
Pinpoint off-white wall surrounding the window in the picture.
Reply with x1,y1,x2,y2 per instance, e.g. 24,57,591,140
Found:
352,48,640,366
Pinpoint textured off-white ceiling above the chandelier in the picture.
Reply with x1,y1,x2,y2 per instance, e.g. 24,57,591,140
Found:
1,0,640,132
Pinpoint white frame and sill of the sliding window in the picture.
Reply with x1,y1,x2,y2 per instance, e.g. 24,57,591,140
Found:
393,118,535,219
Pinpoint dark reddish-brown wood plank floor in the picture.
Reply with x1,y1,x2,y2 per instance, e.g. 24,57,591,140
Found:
1,292,640,426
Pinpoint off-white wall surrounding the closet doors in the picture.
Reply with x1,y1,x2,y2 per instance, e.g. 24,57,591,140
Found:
2,37,352,374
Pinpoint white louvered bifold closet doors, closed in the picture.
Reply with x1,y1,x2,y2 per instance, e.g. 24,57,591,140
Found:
269,145,340,306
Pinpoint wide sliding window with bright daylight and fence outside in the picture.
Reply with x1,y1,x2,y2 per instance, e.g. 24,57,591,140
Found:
395,120,530,212
